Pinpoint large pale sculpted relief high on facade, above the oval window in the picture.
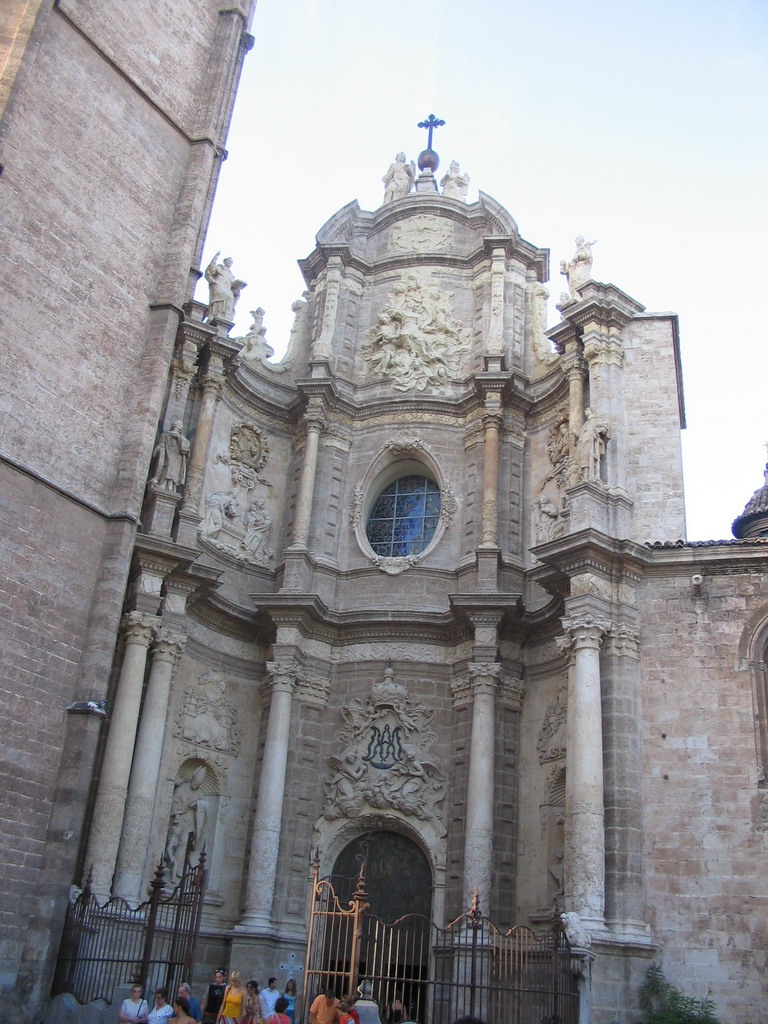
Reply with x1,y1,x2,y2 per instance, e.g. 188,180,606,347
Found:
361,274,470,391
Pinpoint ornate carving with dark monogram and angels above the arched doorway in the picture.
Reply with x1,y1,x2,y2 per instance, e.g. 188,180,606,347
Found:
324,667,445,821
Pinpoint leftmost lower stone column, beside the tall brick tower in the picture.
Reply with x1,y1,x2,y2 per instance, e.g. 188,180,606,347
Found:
85,611,160,896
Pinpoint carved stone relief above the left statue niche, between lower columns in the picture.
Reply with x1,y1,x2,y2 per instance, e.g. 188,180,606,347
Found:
173,669,241,755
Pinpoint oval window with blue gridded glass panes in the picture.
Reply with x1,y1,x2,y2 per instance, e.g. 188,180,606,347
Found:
366,475,440,558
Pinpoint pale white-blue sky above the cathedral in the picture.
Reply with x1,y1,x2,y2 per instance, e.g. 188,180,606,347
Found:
198,0,768,540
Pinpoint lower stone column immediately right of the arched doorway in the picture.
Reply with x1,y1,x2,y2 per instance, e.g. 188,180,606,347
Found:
463,662,502,913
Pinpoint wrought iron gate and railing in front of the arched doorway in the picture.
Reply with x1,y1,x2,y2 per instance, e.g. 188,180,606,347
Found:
297,865,579,1024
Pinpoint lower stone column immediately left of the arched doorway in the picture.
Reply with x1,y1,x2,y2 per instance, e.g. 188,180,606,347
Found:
238,662,301,931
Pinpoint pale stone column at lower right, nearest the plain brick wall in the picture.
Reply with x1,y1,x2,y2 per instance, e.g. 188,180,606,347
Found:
558,613,610,931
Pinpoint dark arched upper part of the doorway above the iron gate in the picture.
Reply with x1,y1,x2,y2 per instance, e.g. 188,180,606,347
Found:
330,830,432,924
